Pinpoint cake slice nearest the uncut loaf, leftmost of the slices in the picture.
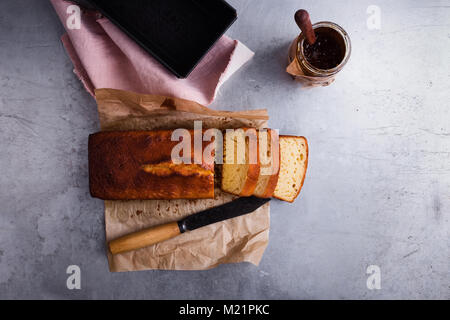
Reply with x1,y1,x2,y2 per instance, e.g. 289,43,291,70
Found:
221,128,259,196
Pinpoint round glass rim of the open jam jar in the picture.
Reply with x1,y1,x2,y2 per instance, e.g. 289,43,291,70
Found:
297,21,351,75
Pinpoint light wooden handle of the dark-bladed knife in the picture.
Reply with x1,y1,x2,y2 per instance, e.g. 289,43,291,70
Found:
109,222,181,254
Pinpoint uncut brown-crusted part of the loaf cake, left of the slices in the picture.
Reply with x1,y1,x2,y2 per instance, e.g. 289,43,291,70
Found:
89,130,214,200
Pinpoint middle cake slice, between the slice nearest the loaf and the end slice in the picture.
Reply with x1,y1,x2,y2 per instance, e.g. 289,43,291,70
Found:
253,129,280,198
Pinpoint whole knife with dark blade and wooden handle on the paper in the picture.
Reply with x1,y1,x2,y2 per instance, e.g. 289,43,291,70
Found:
109,196,270,254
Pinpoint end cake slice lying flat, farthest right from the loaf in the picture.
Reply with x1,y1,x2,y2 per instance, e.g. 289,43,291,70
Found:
273,136,308,202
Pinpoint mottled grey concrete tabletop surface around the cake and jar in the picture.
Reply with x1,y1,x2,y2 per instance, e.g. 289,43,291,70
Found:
0,0,450,299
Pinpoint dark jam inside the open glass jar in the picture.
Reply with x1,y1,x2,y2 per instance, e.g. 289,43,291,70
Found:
303,28,345,70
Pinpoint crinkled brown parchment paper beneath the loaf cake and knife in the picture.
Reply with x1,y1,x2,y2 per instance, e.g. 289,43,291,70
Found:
95,89,270,272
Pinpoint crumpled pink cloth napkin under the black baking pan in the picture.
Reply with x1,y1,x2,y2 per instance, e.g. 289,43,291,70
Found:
50,0,254,105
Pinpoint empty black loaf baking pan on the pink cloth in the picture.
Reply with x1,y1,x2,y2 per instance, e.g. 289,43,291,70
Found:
84,0,237,78
